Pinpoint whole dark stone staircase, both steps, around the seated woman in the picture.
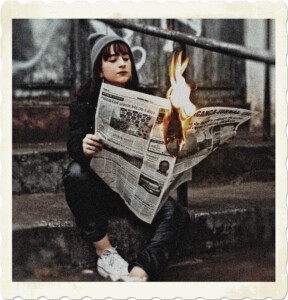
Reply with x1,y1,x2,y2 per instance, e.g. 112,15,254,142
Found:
13,135,275,281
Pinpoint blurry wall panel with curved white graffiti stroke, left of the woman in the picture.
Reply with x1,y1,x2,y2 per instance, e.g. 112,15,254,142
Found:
12,19,71,85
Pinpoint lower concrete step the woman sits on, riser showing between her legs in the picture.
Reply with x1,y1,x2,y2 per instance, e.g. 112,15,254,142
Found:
13,182,275,277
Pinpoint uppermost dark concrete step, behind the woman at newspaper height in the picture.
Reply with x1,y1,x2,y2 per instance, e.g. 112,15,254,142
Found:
13,135,275,194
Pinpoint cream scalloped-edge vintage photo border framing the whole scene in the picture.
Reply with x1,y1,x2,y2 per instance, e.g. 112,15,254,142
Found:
1,1,287,299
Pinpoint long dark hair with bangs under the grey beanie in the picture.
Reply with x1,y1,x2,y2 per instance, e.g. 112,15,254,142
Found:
76,42,139,106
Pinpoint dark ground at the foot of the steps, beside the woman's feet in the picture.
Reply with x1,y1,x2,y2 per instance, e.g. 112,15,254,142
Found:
13,247,275,282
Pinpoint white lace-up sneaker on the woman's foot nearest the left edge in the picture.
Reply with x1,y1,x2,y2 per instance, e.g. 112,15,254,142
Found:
97,248,129,281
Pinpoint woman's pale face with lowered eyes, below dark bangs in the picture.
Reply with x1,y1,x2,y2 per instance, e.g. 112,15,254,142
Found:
100,45,131,87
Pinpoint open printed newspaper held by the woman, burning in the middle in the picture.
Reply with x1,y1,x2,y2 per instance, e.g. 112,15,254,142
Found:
91,84,255,223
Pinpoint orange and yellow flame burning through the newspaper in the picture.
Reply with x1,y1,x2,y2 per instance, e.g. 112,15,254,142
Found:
162,51,196,157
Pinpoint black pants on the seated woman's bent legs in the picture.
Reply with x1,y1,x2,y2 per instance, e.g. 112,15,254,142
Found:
63,161,190,280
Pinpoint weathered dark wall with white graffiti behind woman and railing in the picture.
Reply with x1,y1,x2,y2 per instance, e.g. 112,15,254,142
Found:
13,19,272,143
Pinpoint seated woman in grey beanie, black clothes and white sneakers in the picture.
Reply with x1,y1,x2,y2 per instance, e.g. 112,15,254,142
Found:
63,34,189,281
